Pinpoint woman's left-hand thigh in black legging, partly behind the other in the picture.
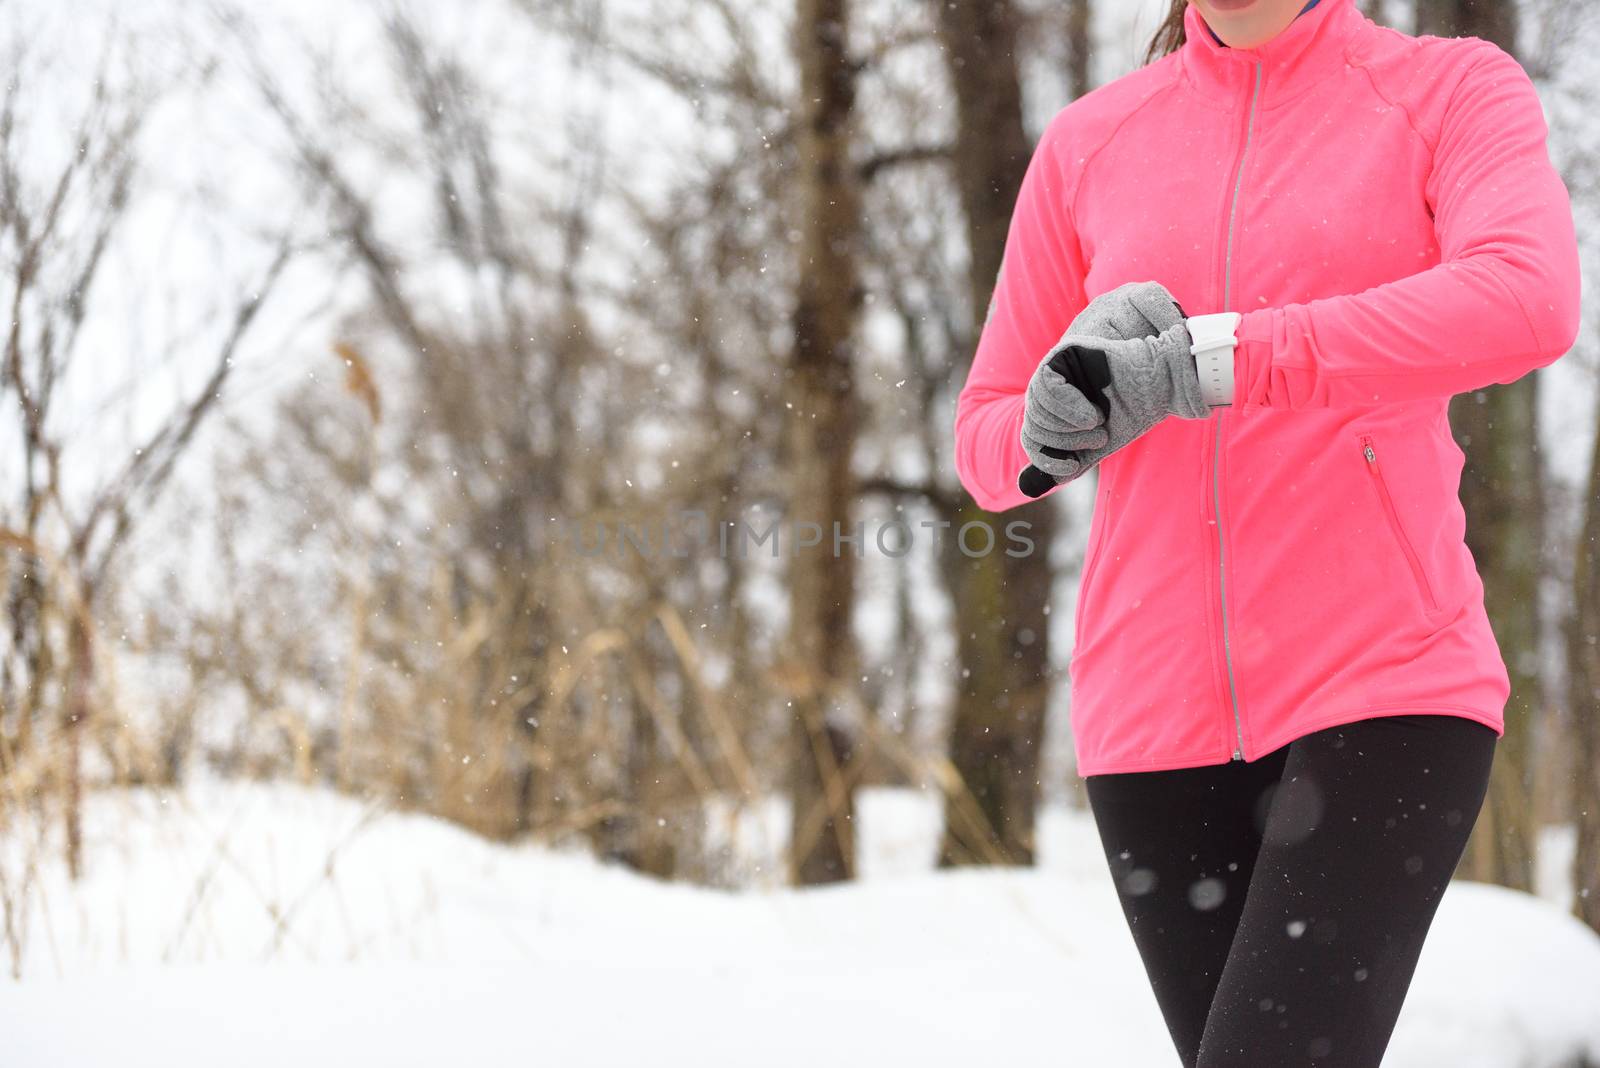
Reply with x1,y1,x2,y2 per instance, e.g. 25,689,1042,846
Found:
1083,750,1286,1065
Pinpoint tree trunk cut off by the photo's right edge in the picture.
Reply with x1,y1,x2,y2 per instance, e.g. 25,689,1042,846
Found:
1566,377,1600,932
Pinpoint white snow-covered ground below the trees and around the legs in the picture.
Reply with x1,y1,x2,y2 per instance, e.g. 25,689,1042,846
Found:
0,785,1600,1068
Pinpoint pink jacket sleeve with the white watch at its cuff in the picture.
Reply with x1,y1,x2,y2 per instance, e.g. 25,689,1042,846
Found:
1234,42,1581,408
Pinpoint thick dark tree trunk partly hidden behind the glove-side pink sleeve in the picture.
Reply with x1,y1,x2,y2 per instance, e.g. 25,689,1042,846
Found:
939,0,1068,867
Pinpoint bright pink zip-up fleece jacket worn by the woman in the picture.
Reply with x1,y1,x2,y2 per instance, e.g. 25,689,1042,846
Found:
955,0,1579,775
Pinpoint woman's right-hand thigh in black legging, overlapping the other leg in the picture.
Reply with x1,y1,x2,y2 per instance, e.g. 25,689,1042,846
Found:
1198,715,1496,1068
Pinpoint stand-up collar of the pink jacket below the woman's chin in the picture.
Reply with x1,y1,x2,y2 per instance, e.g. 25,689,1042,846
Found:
1178,0,1368,109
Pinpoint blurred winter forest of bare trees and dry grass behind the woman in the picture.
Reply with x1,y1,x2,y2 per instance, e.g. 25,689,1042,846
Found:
0,0,1600,952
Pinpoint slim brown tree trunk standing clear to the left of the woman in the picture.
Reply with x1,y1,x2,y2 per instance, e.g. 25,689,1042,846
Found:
784,0,861,884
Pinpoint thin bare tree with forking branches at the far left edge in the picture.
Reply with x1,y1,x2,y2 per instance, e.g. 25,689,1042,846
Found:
0,39,291,876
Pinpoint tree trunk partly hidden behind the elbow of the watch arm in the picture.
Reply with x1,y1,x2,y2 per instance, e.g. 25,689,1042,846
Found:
1416,0,1547,891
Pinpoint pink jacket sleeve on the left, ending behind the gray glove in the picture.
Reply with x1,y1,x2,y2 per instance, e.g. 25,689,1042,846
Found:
955,109,1088,512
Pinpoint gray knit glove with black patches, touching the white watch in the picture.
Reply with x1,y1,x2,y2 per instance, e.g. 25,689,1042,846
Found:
1018,281,1211,497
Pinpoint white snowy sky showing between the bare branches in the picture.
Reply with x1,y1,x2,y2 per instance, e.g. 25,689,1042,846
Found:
0,0,1600,777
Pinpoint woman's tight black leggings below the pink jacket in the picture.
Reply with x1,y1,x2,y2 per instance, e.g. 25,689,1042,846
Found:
1085,715,1496,1068
